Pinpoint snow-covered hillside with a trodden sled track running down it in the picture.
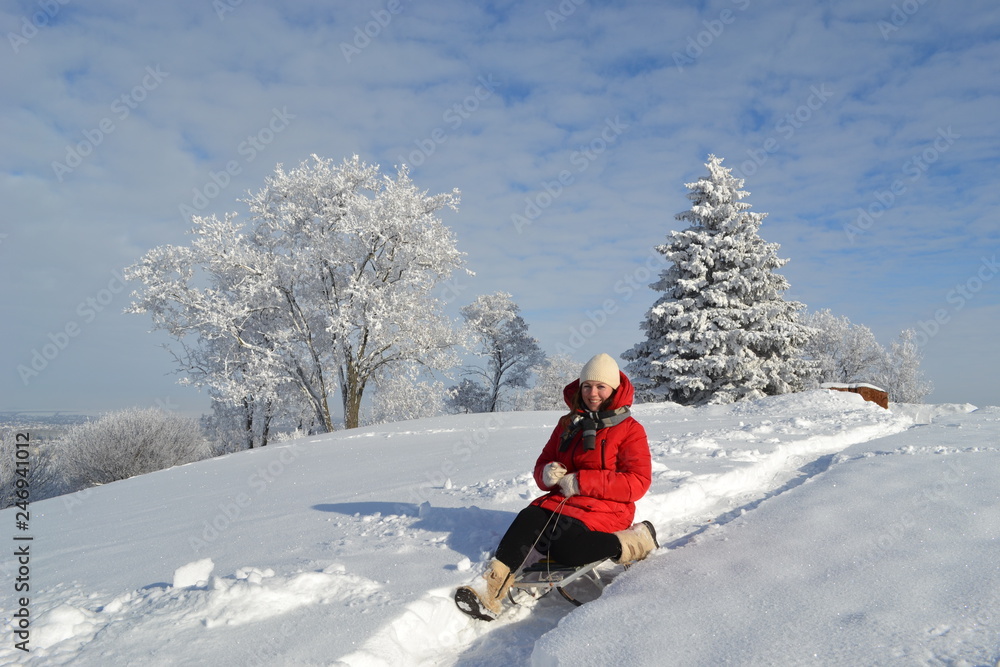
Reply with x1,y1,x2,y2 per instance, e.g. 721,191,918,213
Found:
0,390,1000,667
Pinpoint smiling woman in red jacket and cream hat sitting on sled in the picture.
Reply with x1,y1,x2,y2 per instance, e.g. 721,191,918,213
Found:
455,353,659,621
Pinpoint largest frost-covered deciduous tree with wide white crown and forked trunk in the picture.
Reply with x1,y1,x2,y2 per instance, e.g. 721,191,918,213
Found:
126,155,463,431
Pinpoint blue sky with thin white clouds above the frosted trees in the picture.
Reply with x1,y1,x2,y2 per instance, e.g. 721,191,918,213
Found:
0,0,1000,413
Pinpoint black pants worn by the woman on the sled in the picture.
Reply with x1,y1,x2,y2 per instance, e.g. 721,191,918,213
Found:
496,505,621,570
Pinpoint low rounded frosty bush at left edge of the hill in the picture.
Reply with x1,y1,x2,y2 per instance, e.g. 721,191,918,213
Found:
59,408,210,489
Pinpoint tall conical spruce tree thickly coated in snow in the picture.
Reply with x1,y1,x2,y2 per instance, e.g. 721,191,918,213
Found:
622,155,812,405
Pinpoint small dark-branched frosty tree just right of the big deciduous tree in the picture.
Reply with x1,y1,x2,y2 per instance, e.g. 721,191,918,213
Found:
452,292,545,412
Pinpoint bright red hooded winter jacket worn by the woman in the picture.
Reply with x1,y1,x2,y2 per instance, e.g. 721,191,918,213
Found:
531,371,652,533
